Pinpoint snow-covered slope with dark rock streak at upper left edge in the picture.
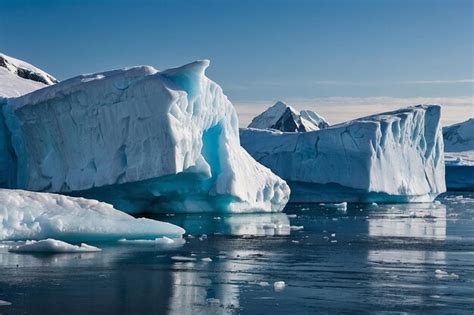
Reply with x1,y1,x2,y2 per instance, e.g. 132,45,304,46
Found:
0,53,58,98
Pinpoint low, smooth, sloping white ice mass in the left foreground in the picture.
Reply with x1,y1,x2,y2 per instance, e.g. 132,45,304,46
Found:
0,189,185,242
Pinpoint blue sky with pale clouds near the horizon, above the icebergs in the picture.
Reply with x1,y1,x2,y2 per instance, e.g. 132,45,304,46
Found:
0,0,474,126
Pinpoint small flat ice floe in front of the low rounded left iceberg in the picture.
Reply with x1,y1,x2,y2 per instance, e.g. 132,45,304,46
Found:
8,238,101,253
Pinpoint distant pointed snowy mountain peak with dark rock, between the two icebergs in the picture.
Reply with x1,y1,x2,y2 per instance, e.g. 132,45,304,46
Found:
249,101,329,132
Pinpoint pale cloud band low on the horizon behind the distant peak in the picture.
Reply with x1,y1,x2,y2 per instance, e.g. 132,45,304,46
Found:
233,96,474,127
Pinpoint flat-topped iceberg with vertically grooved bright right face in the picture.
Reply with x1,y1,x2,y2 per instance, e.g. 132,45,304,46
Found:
240,105,446,202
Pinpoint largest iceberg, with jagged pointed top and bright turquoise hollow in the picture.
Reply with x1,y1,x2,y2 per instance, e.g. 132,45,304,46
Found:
0,60,289,212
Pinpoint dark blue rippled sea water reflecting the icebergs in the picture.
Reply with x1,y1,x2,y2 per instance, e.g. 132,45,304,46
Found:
0,193,474,314
